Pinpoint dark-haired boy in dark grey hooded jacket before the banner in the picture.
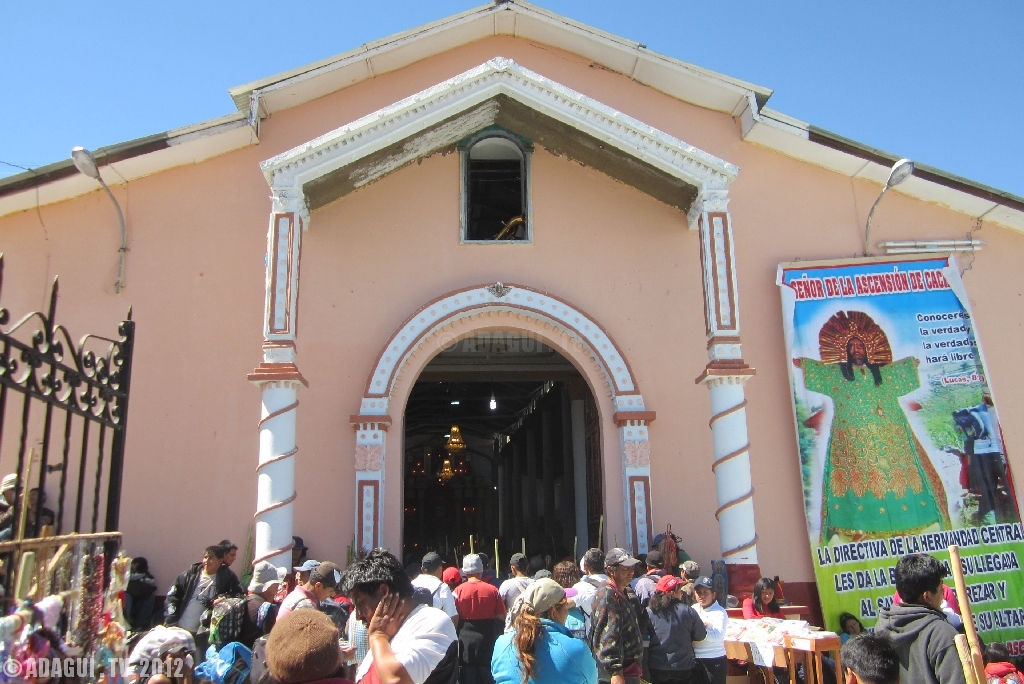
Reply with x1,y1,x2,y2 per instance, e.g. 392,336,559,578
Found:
874,554,966,684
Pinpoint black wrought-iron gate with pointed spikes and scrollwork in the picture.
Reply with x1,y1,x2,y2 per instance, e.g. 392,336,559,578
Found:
0,254,135,596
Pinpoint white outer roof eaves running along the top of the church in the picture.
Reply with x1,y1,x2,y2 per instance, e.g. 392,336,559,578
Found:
0,0,1024,231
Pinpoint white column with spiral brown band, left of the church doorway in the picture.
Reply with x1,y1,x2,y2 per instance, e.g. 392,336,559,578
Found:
249,187,309,568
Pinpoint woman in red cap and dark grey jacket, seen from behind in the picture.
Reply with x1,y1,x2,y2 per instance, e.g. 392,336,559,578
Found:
647,574,708,684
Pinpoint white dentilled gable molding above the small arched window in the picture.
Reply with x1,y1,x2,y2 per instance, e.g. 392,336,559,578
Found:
261,57,739,202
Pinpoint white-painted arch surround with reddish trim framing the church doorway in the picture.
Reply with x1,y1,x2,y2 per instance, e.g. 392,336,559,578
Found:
350,283,654,553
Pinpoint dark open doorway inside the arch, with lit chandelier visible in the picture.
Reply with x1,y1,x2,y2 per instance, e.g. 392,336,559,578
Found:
402,329,604,562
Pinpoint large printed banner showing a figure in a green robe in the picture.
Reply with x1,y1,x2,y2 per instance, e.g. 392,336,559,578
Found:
778,257,1024,654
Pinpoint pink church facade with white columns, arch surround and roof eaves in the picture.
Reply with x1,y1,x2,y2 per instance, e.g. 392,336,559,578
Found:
0,3,1024,618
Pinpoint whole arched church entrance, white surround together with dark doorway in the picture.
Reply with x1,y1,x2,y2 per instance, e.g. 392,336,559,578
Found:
351,283,654,558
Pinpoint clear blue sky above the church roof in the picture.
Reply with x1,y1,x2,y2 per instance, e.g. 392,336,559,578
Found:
0,0,1024,196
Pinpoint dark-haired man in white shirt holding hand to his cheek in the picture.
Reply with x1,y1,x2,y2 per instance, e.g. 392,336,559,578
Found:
342,549,459,684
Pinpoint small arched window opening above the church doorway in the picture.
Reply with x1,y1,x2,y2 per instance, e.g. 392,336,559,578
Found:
463,135,529,242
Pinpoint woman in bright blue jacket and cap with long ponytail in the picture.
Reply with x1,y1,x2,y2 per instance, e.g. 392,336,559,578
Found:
490,578,597,684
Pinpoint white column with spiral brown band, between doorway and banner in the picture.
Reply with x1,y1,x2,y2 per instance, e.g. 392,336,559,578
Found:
690,188,761,598
